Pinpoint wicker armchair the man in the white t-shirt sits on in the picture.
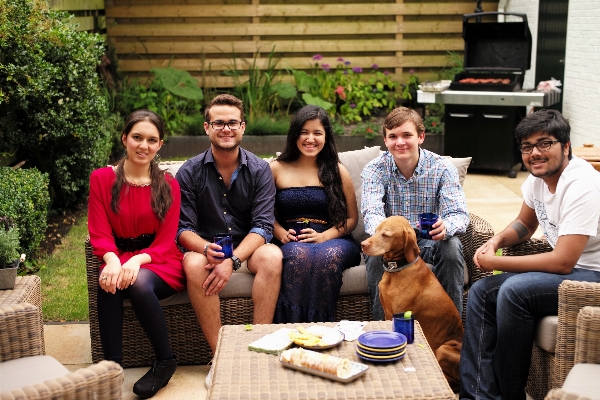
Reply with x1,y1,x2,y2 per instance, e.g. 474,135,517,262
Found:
502,239,600,400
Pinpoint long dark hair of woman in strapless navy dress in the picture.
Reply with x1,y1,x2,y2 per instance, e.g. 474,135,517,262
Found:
277,105,348,229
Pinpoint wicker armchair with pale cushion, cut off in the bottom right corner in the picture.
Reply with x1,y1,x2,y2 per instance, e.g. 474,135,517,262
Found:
546,304,600,400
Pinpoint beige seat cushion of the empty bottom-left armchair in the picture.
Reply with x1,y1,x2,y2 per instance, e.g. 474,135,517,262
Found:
0,356,69,393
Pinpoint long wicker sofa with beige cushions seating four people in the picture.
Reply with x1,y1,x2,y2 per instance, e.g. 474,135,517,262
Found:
86,146,493,367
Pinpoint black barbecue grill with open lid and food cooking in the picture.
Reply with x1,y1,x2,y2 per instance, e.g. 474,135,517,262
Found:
417,12,560,178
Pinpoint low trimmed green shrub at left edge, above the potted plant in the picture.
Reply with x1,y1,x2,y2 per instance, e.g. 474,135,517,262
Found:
0,167,50,255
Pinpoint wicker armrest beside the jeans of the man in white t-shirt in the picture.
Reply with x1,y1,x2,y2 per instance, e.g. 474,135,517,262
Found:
555,280,600,386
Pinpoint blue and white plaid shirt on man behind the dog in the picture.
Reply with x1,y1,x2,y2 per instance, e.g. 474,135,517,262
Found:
360,149,469,237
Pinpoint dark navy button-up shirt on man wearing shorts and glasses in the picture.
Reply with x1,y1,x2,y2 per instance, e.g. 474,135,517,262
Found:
177,148,275,246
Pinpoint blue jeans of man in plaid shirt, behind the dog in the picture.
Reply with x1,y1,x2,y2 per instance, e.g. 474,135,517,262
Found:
365,236,465,321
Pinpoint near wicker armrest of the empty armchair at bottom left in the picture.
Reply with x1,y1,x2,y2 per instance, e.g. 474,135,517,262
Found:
2,361,123,400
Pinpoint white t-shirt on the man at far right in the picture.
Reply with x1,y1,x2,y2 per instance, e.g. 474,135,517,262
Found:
521,156,600,271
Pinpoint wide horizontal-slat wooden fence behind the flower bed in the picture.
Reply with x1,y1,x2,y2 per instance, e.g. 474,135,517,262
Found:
105,0,498,87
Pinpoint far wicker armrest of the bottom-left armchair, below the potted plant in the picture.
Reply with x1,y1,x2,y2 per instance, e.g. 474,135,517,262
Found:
0,303,44,362
